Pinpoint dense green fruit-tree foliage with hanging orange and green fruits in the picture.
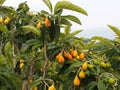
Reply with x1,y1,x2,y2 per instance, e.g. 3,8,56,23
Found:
0,0,120,90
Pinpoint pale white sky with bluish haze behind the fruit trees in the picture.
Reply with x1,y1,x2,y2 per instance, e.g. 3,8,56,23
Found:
4,0,120,39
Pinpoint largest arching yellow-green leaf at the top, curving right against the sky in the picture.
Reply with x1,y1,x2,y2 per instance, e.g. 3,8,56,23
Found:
54,1,87,15
